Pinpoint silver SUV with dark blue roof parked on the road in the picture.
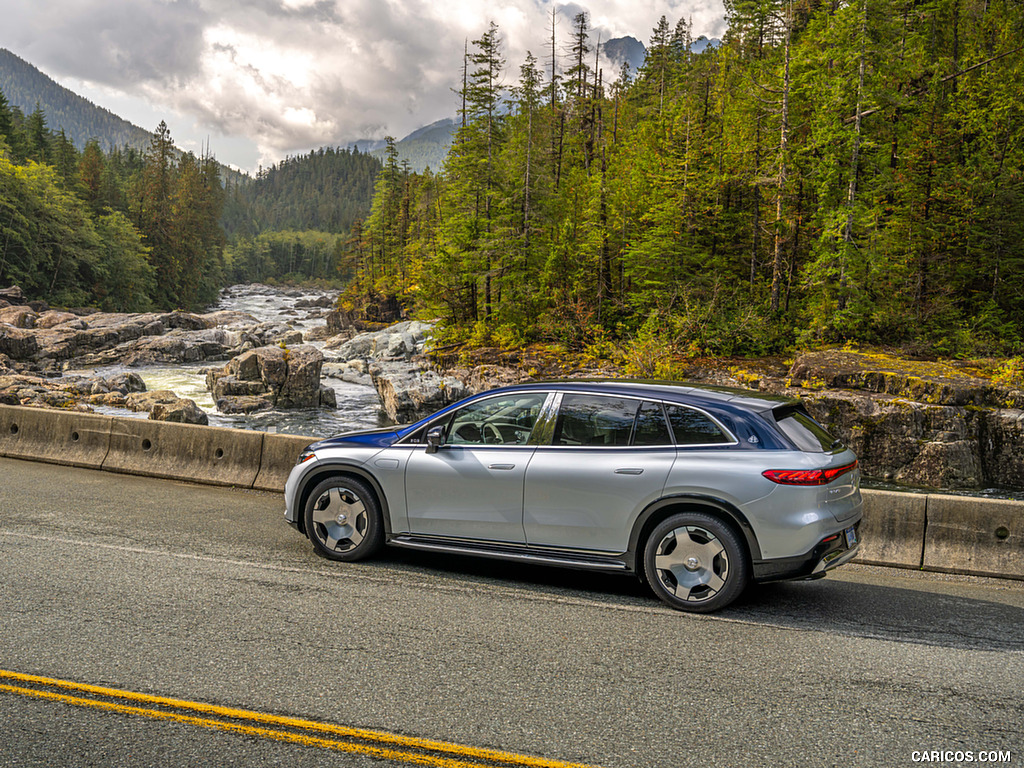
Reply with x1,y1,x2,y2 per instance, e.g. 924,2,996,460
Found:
285,381,862,611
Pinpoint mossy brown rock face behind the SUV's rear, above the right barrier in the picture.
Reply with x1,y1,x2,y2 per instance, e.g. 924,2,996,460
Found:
758,350,1024,489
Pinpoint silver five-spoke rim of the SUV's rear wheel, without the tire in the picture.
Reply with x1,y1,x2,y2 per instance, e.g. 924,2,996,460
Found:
654,525,729,603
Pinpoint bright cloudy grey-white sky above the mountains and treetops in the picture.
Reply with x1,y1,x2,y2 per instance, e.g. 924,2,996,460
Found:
0,0,725,171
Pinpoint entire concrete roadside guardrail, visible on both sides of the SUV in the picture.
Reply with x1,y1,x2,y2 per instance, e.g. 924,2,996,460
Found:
0,406,1024,580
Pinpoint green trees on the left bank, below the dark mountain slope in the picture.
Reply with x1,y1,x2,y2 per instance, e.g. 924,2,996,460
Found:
0,100,224,311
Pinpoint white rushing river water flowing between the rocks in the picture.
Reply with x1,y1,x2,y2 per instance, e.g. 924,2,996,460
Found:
68,285,387,437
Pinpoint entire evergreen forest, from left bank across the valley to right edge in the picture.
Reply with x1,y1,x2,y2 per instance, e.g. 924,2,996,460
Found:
0,0,1024,364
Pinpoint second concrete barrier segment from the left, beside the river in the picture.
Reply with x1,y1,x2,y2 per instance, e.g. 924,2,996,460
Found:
102,417,263,487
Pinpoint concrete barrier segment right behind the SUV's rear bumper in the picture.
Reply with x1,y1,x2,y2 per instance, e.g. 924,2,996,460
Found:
854,489,928,568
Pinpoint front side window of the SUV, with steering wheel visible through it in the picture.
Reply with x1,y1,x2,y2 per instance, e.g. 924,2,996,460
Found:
445,392,548,445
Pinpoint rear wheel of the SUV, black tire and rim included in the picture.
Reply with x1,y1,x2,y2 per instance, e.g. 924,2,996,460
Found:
643,512,750,613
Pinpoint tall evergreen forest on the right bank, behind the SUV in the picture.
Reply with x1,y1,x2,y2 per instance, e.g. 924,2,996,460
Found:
344,0,1024,355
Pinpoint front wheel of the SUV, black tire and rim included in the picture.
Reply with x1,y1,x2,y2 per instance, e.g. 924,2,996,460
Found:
305,475,384,562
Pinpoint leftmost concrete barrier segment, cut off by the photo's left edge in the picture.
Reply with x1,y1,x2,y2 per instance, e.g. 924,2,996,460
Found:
0,406,113,469
